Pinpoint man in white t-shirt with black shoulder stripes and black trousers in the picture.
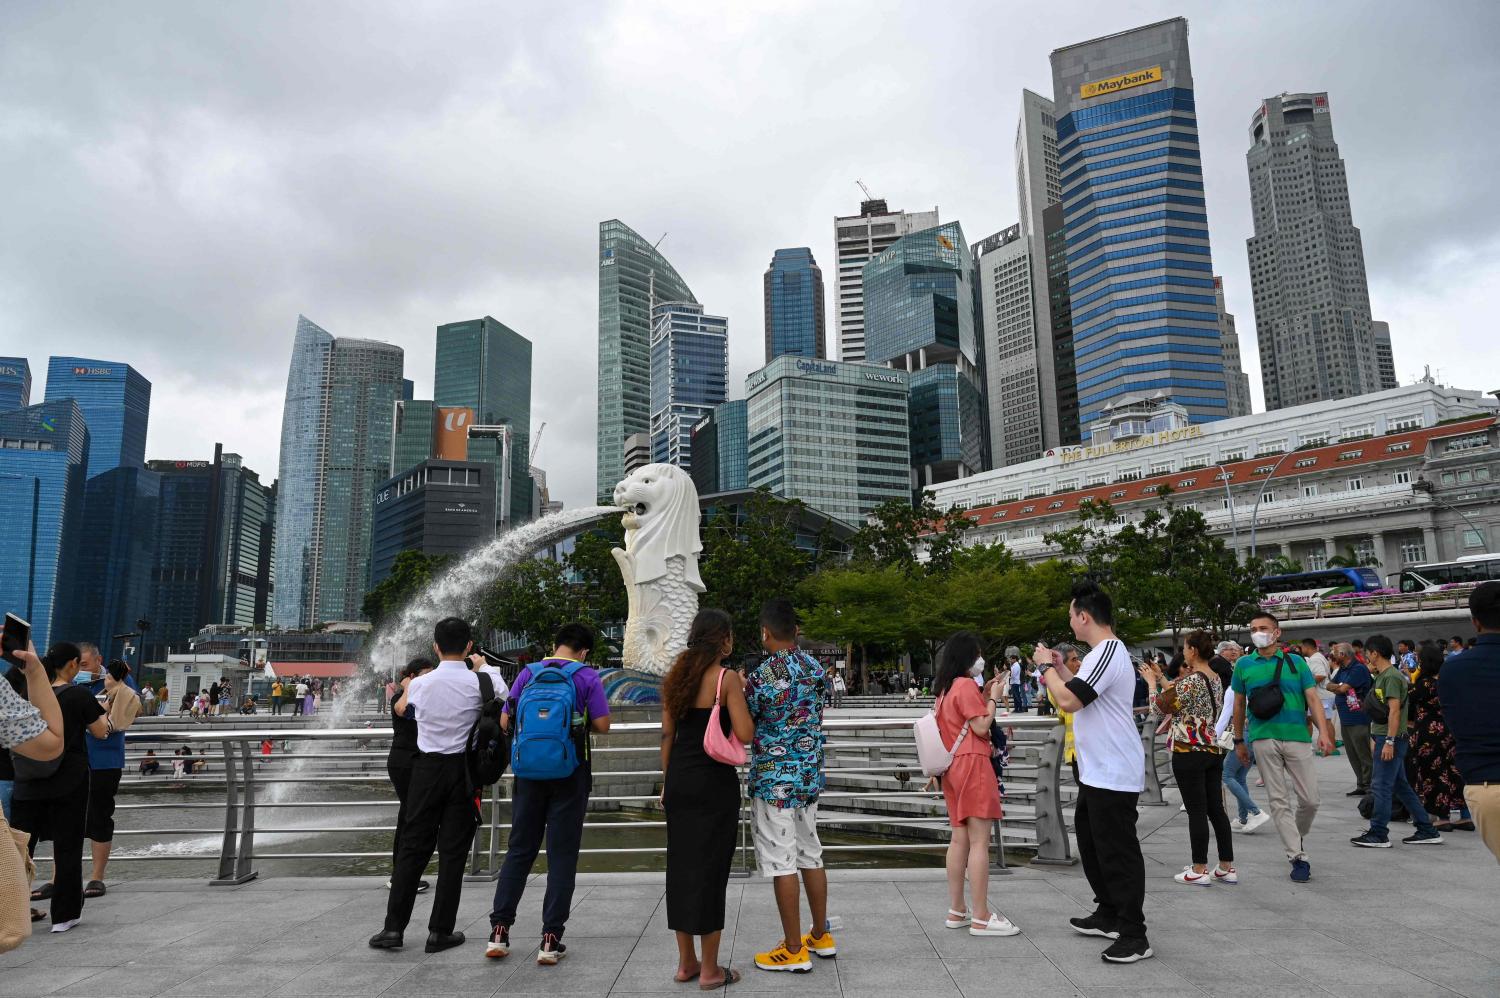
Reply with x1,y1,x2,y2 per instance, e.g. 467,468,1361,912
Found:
1037,581,1152,963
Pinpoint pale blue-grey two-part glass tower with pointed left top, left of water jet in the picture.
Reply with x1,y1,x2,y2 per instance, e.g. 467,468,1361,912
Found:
272,315,402,627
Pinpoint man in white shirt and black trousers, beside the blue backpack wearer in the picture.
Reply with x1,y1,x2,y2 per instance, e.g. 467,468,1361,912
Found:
371,617,482,953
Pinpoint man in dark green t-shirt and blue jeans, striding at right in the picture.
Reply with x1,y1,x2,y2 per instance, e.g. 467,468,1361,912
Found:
1350,635,1443,849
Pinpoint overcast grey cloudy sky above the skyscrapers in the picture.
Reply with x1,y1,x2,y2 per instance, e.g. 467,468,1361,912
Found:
0,0,1500,506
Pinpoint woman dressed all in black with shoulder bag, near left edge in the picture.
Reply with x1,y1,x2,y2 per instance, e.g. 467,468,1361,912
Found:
11,641,110,932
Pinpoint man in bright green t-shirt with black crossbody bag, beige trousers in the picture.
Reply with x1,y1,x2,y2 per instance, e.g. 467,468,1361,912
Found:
1230,611,1334,884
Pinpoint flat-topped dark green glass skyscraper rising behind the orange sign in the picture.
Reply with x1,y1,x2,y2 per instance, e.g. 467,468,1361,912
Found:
435,315,531,524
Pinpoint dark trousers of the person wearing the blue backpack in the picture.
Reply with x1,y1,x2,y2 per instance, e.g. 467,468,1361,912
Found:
489,764,594,936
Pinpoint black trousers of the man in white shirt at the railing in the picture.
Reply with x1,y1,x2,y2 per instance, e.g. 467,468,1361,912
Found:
386,752,479,932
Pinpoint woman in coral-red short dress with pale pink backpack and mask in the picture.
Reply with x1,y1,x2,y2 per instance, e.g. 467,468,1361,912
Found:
933,630,1020,935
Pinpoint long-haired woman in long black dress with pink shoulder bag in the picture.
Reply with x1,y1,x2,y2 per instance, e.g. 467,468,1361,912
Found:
662,609,755,990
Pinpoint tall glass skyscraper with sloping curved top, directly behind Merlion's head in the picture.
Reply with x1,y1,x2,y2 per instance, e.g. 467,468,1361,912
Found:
594,219,698,503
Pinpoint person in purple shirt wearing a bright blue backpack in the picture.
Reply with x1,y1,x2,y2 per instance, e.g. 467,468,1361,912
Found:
485,623,609,966
